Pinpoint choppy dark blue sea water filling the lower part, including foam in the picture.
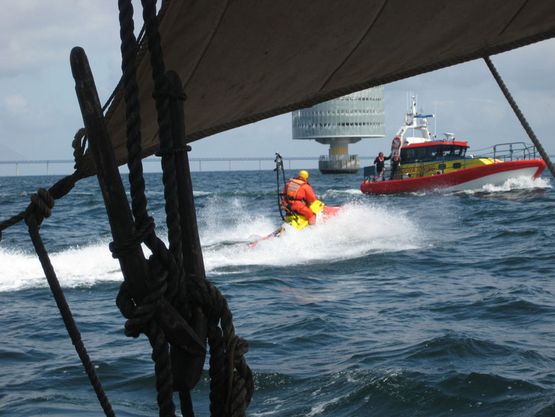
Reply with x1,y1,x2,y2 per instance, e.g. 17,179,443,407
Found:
0,171,555,417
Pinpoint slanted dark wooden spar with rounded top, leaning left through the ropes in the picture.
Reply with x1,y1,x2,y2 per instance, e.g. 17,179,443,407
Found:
70,48,206,355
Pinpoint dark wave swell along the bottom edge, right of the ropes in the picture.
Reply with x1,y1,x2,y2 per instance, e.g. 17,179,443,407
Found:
252,367,550,417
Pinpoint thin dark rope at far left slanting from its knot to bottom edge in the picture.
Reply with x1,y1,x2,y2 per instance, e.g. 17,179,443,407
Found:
25,189,115,417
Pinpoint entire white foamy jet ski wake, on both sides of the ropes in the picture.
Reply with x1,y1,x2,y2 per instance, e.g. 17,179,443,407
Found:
0,198,424,292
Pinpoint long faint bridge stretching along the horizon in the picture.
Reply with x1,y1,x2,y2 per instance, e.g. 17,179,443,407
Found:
0,156,373,176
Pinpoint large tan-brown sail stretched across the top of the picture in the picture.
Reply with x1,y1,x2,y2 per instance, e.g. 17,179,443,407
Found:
76,0,555,174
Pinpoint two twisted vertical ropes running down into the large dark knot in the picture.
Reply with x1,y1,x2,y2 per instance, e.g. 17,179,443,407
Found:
113,0,253,416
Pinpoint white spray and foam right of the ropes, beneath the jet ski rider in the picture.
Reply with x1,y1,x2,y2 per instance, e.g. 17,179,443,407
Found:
204,203,422,271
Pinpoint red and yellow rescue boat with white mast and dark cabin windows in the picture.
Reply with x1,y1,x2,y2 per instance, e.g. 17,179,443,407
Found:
360,97,546,194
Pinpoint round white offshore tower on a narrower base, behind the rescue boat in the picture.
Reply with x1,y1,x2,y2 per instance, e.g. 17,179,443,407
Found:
292,86,384,174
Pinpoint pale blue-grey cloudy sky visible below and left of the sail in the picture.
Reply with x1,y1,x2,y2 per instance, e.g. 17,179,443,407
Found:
0,0,555,175
